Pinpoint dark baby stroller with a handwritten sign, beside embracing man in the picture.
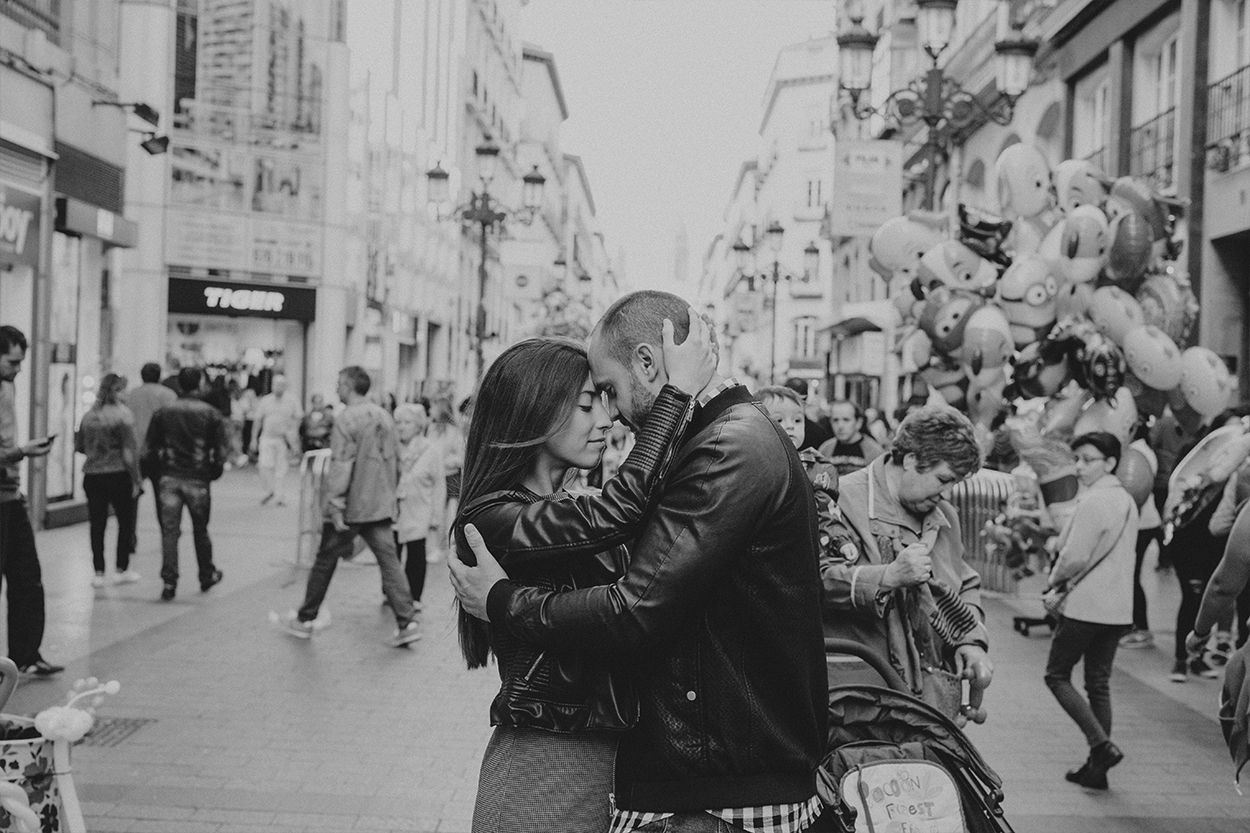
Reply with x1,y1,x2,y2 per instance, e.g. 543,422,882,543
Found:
813,639,1013,833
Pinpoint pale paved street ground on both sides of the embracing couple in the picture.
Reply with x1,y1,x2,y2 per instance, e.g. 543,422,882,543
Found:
6,472,1250,833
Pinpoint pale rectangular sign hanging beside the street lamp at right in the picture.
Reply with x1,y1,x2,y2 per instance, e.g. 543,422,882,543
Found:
829,140,903,238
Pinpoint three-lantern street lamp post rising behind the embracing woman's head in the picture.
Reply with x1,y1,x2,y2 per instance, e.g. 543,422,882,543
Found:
425,136,546,378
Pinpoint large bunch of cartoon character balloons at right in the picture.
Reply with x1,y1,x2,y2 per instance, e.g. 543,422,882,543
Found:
870,144,1233,527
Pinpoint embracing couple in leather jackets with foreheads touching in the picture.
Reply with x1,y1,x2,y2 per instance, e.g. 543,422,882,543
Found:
451,291,828,833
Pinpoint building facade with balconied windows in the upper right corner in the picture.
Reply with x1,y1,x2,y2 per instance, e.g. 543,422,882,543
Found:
1044,0,1250,398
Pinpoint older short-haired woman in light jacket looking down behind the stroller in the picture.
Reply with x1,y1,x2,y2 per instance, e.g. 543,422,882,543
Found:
820,406,993,719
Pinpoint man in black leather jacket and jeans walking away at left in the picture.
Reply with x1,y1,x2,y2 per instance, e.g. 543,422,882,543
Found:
144,368,230,602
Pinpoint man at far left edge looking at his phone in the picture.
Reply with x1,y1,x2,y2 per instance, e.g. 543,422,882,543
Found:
0,325,65,677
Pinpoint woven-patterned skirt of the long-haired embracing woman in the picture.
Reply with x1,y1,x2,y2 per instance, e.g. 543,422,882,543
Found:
473,727,619,833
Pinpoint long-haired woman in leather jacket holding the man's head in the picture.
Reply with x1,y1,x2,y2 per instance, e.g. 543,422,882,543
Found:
455,314,715,833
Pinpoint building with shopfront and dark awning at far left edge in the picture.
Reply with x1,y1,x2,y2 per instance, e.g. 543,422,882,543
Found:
0,0,143,527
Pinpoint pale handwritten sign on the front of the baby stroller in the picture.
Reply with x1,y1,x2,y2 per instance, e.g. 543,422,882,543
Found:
841,760,968,833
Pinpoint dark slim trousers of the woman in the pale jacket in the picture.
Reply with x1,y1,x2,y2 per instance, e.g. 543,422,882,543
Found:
1046,617,1129,749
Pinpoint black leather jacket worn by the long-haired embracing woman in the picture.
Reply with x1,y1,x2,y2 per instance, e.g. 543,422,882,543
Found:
456,385,693,732
